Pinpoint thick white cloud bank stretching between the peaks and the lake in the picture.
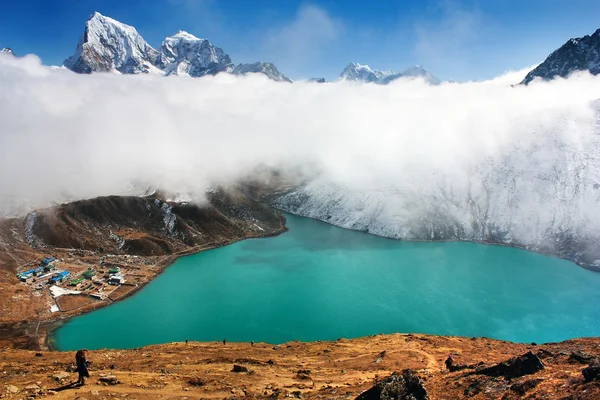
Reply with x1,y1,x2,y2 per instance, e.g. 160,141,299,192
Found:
0,56,600,256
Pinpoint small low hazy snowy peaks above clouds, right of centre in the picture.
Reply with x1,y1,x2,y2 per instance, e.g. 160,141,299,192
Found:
340,62,440,85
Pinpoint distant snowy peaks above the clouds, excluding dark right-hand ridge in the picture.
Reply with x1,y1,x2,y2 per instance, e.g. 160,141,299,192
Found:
58,12,440,84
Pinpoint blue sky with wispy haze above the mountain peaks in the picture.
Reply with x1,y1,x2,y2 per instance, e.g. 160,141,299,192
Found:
0,0,600,81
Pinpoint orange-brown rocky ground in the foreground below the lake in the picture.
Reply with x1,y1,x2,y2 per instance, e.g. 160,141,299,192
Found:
0,334,600,400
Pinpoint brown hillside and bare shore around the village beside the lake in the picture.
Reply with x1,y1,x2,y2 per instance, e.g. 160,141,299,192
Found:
0,188,285,348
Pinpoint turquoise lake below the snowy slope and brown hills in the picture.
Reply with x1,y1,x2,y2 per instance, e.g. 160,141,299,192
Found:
54,215,600,350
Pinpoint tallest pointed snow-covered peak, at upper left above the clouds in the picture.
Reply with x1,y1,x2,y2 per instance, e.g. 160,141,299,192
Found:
64,12,160,74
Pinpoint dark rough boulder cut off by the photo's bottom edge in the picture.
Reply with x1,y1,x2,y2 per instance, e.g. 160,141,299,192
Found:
356,369,429,400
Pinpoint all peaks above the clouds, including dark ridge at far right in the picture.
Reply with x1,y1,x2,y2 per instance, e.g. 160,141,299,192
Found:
5,12,600,85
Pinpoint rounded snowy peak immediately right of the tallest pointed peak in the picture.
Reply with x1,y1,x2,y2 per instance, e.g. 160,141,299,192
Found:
157,31,233,77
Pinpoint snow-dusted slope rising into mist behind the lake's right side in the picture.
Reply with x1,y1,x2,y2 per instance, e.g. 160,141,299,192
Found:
273,102,600,267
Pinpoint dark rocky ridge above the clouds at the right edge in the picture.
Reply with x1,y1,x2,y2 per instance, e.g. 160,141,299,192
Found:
521,29,600,84
